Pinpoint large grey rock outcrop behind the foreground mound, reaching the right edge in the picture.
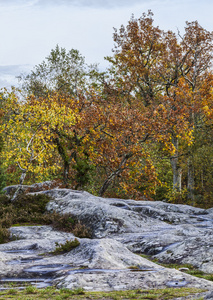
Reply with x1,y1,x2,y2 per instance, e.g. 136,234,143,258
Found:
44,189,213,273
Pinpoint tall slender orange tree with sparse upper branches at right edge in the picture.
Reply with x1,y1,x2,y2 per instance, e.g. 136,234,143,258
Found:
181,22,213,201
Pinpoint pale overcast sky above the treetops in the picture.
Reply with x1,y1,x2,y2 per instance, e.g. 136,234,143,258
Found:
0,0,213,87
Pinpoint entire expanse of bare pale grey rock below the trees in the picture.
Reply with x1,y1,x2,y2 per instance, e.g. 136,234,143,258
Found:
0,188,213,299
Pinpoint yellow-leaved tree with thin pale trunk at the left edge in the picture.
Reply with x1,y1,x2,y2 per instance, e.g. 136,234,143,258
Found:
0,92,75,200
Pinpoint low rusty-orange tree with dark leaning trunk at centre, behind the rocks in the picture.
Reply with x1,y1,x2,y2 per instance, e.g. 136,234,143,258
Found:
80,90,156,197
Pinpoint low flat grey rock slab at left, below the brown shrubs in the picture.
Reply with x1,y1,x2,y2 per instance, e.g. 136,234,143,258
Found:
0,226,75,277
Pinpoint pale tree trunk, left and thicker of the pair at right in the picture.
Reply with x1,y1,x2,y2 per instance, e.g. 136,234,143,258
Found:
170,137,182,192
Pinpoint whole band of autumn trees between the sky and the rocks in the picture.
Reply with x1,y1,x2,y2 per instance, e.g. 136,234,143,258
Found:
0,11,213,209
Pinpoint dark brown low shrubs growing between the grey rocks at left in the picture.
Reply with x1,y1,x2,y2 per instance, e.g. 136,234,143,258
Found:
0,194,91,245
